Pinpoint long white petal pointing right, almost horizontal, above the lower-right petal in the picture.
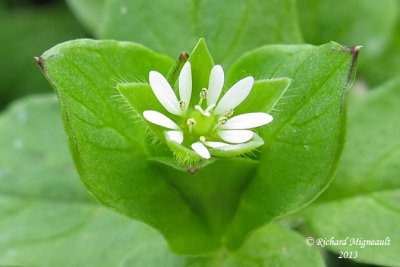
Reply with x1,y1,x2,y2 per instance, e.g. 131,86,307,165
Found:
221,112,273,130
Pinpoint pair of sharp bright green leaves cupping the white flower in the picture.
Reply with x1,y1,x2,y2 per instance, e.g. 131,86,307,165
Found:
38,40,355,255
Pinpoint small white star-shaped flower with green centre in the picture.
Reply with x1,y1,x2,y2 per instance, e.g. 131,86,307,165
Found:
143,61,273,159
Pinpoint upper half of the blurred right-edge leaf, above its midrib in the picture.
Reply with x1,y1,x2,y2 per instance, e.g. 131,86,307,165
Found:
321,78,400,200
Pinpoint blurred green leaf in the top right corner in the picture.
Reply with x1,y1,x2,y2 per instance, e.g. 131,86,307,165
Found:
297,0,400,85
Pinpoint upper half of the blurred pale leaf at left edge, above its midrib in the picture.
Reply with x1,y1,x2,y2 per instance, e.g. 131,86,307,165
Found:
0,95,94,203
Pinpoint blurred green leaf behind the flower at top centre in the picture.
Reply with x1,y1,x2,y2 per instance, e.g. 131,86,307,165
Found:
69,0,301,65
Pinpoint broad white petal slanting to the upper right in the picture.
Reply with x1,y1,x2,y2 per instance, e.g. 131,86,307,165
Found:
214,76,254,115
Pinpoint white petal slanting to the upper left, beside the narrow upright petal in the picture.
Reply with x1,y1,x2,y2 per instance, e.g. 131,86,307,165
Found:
149,71,182,116
